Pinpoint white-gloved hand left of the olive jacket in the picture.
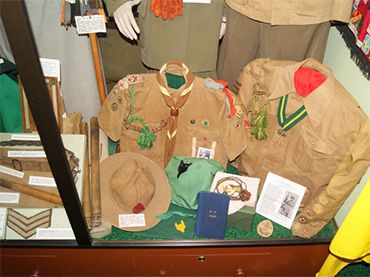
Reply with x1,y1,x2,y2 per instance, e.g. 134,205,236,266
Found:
113,0,141,40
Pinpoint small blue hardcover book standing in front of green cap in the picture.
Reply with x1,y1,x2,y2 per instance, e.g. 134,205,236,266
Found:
195,191,230,239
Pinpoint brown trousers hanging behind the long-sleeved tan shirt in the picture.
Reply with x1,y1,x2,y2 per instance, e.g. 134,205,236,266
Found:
217,7,330,89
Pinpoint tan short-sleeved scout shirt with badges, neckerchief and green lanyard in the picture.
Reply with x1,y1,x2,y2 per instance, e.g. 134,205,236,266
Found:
99,62,247,167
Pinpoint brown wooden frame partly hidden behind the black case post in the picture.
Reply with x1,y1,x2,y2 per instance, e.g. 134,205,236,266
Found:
19,77,63,133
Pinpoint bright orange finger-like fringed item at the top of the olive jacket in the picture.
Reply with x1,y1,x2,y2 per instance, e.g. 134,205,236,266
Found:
150,0,182,20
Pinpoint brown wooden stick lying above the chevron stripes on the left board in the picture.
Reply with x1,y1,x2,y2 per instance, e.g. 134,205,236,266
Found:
0,179,63,206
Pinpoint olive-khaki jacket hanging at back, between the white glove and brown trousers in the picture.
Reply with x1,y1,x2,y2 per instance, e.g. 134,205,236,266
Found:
105,0,224,72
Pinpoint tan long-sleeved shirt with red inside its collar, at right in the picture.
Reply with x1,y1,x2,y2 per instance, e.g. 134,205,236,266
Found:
238,58,370,237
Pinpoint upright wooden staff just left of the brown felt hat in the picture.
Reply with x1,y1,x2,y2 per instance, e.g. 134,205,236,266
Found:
90,117,101,227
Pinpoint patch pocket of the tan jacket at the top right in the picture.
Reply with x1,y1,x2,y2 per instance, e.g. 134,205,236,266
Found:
294,0,333,17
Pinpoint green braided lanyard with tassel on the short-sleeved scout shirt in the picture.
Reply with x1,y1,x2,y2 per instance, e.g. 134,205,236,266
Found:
126,84,156,149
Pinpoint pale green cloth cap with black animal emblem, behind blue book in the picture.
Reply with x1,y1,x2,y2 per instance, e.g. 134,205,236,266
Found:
165,156,225,210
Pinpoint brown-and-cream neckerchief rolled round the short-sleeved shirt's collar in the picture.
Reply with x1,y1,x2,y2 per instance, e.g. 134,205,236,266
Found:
157,61,194,98
